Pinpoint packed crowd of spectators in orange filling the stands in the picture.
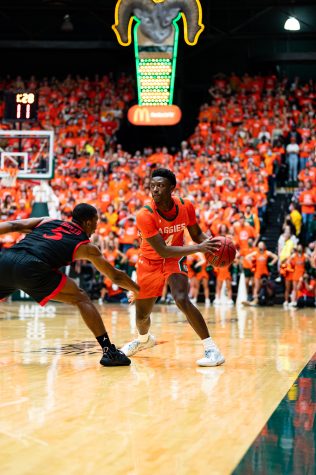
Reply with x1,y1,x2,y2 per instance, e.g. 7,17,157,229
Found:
0,74,316,305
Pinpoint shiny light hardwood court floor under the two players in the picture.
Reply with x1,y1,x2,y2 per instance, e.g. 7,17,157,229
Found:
0,303,316,475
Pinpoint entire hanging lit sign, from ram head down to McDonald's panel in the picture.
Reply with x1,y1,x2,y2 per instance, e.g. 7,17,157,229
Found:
112,0,205,126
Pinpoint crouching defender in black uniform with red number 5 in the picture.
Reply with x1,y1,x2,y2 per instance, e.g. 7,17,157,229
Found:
0,203,139,366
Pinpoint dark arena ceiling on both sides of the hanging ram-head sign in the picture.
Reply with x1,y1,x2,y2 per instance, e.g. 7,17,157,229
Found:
0,0,316,49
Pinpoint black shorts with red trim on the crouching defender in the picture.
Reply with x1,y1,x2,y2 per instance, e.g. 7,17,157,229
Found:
0,250,67,306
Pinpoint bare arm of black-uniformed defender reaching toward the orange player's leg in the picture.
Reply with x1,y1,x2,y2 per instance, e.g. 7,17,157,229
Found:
74,244,139,294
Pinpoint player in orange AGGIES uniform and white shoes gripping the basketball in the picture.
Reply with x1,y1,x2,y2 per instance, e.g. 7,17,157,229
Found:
121,168,225,366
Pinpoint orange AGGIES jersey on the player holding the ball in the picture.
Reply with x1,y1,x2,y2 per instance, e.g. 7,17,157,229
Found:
136,196,196,260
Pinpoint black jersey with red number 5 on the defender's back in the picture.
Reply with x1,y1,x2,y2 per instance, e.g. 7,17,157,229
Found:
11,219,90,269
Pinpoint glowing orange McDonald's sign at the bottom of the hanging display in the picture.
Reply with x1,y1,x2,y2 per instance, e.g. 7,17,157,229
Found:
128,106,182,126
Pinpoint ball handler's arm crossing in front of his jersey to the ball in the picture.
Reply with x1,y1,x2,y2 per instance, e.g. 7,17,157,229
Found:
146,234,221,259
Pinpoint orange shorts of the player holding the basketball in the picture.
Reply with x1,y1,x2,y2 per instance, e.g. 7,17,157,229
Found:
136,256,188,300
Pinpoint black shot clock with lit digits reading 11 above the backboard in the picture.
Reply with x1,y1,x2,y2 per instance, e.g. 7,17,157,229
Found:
4,91,38,122
